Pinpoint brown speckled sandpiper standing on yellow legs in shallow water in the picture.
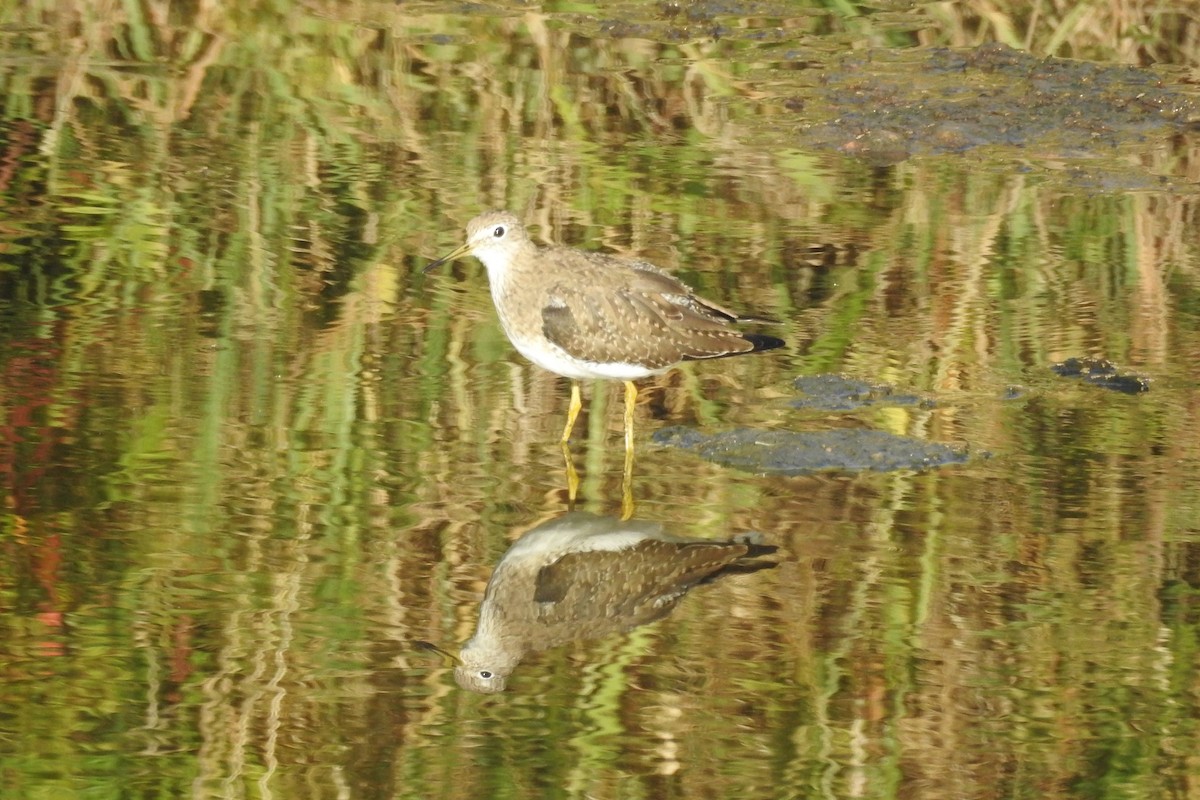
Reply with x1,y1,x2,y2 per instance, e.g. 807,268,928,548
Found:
425,211,784,452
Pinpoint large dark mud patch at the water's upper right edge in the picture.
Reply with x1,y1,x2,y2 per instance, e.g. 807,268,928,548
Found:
778,44,1200,191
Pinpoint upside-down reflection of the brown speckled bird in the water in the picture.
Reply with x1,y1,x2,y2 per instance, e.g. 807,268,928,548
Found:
455,512,776,693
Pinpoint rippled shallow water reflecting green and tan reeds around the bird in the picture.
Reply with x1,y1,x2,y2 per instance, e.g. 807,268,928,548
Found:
0,4,1200,799
